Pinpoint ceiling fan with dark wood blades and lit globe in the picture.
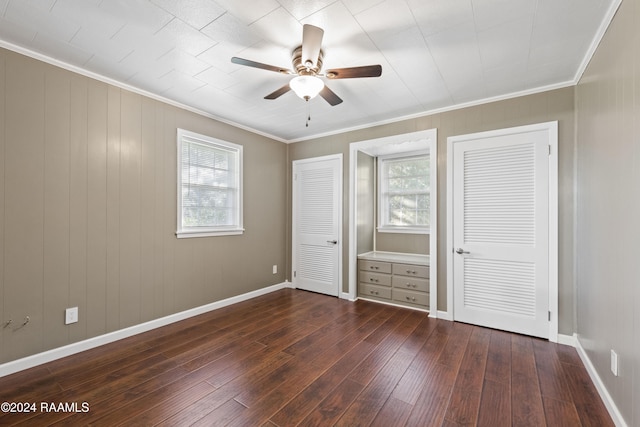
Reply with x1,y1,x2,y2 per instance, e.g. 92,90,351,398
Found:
231,24,382,105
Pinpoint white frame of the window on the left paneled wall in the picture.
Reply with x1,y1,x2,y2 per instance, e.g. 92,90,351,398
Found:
176,129,244,239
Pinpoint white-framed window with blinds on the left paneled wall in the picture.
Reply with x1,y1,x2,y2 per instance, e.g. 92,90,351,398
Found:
176,129,244,238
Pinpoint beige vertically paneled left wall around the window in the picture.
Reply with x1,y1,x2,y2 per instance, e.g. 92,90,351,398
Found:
0,50,287,363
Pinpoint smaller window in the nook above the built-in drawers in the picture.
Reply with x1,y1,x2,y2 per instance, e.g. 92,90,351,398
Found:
378,152,431,234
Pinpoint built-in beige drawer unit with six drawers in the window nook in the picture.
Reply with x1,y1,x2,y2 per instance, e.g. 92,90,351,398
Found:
358,254,429,309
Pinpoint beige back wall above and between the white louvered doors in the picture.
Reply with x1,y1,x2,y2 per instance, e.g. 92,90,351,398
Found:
288,88,575,335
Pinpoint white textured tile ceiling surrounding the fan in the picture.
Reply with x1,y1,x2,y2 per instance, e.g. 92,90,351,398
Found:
0,0,620,141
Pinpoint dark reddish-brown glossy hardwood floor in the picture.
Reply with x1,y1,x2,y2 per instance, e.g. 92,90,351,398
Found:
0,289,613,427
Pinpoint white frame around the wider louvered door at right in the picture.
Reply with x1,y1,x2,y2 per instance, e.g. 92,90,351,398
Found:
446,121,558,342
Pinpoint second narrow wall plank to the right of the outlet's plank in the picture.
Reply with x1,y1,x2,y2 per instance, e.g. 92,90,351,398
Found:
106,86,121,332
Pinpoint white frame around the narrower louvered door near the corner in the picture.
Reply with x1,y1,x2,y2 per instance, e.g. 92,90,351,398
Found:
291,153,344,298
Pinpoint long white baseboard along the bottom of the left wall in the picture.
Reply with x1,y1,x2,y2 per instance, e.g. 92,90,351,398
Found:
0,282,291,378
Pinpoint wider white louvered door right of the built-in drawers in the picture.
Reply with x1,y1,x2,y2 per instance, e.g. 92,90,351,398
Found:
452,131,549,338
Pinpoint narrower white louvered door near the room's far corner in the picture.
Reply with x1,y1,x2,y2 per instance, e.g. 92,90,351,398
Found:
292,156,342,296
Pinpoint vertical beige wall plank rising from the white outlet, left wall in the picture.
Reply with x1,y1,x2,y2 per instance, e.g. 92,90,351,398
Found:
67,76,88,342
